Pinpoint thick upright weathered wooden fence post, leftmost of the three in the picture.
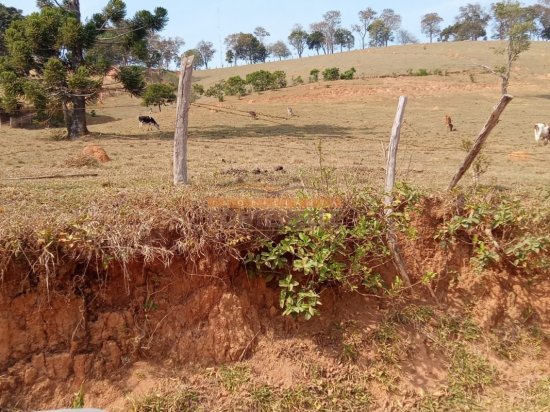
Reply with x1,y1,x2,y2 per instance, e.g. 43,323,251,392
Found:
174,56,194,185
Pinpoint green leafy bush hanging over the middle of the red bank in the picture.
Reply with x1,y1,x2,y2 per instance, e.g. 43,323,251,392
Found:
247,197,396,319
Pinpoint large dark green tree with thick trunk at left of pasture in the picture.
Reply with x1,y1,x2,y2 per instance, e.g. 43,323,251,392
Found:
0,0,168,139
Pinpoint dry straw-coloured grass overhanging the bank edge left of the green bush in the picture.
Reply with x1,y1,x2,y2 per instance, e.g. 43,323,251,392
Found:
0,188,288,286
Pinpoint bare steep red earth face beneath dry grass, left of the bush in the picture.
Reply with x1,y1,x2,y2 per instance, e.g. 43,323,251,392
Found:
0,253,278,407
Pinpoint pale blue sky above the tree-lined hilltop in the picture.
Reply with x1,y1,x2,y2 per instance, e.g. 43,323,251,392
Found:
0,0,534,67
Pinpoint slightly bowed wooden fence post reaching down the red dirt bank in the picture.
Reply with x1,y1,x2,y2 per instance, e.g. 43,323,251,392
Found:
384,96,411,287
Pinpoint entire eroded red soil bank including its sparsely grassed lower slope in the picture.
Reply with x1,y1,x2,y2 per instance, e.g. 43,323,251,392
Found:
0,197,550,410
